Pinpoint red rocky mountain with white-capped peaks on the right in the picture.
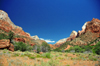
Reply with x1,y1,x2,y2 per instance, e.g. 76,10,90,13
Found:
55,18,100,49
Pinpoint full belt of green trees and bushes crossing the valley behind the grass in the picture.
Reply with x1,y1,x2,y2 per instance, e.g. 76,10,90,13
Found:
0,31,100,55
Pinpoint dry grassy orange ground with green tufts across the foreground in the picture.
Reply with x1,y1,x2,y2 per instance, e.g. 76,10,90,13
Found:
0,50,100,66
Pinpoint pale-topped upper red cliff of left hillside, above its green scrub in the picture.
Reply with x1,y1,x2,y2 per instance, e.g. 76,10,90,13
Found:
0,10,30,37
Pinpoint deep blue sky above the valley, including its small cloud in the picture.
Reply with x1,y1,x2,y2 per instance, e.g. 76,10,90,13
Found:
0,0,100,44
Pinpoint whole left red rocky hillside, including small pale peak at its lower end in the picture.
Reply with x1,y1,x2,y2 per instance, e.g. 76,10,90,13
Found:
0,10,46,51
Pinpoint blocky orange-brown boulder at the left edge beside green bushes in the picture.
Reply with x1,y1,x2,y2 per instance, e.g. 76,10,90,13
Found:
0,39,14,51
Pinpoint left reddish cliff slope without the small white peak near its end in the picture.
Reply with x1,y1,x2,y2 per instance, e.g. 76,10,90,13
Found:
0,10,45,45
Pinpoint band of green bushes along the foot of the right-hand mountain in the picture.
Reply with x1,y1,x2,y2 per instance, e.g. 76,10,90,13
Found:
53,41,100,55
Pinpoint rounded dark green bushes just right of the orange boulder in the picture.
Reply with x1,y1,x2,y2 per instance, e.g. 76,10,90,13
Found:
14,42,32,51
